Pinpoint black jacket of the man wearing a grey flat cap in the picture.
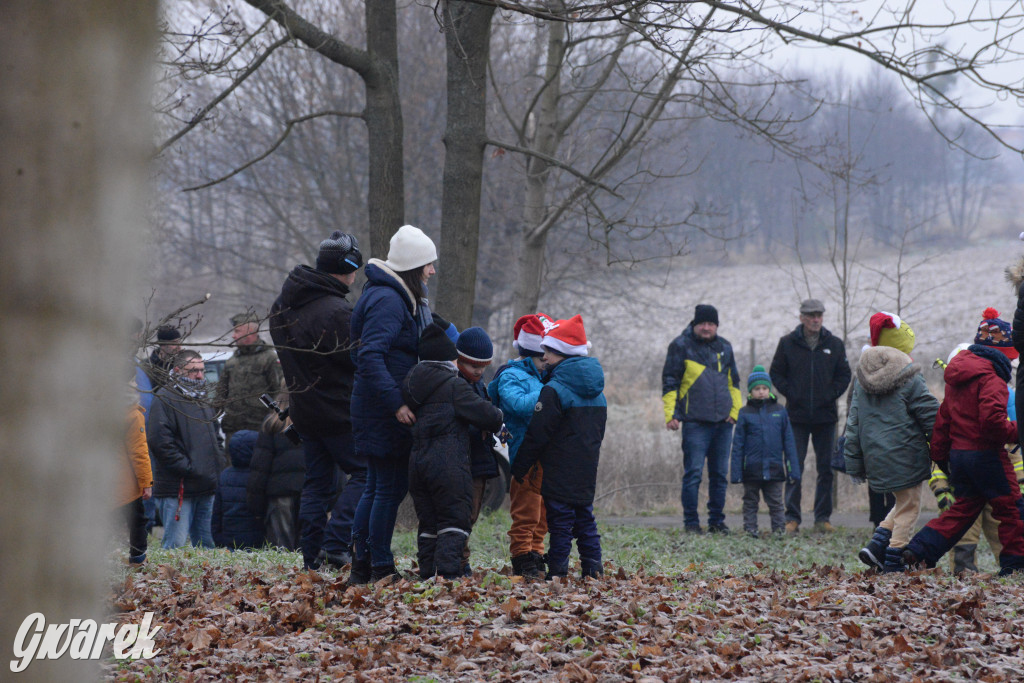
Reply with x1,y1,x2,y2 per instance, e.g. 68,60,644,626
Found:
768,325,852,425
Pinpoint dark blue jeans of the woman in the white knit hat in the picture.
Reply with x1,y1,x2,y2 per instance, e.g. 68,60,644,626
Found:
352,452,409,567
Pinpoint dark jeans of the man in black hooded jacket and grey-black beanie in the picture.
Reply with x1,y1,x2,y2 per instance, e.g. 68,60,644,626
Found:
299,433,367,568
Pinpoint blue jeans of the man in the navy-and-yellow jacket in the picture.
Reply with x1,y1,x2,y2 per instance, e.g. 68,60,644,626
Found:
684,422,732,526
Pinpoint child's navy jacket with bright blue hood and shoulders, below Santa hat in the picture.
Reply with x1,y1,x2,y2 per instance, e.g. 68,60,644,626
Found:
512,356,608,506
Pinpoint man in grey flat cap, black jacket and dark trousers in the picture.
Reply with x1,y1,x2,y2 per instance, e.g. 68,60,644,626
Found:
769,299,851,533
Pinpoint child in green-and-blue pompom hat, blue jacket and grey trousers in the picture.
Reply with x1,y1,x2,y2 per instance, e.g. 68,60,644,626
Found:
731,366,800,538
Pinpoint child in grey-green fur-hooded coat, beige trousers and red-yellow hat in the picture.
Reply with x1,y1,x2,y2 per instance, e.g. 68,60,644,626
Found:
843,311,937,571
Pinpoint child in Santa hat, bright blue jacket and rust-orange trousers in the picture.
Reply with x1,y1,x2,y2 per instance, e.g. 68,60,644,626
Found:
487,313,554,579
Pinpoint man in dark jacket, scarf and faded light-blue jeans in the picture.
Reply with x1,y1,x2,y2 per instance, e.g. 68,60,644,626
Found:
145,350,221,549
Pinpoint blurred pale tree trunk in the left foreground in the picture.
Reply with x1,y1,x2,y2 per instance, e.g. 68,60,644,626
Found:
0,0,156,681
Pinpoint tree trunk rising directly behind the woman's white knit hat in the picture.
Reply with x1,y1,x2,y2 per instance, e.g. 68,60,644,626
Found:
364,0,406,258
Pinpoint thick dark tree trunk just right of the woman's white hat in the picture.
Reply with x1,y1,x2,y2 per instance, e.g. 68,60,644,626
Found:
436,0,495,329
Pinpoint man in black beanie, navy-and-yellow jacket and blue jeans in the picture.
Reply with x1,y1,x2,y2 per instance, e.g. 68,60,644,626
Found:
662,304,743,533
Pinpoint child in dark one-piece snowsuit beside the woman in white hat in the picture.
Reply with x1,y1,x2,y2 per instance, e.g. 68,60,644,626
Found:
401,323,503,579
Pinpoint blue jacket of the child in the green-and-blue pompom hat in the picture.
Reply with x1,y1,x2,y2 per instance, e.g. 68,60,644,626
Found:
729,396,800,483
